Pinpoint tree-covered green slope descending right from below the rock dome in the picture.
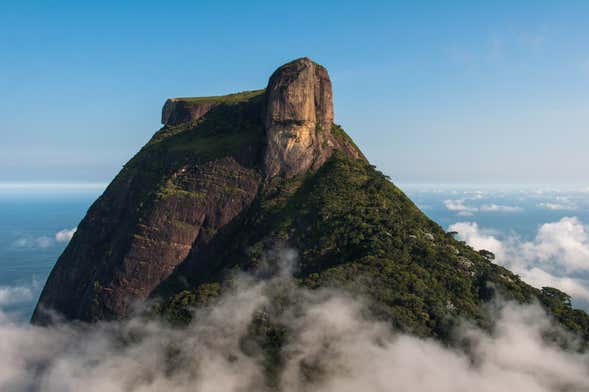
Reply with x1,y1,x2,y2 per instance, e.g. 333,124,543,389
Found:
158,145,589,340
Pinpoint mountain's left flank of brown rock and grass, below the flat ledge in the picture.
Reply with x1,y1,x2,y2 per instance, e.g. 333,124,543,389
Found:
32,94,264,324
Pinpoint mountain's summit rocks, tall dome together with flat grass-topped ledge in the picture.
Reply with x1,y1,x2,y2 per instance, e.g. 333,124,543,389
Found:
162,57,363,178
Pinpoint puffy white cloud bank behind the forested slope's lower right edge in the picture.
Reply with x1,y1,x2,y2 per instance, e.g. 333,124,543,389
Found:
449,217,589,307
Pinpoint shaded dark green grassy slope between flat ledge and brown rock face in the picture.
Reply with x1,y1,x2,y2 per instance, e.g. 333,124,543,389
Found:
97,92,264,222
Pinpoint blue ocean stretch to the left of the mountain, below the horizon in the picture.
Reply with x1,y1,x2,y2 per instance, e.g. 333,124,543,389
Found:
0,187,102,319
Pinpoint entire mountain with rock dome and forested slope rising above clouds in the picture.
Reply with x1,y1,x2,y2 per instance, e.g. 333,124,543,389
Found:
32,58,589,340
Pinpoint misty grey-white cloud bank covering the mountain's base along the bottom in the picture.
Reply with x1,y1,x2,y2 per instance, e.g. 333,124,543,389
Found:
0,270,589,392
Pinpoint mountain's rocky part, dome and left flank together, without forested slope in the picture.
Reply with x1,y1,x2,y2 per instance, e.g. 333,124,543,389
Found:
32,58,361,324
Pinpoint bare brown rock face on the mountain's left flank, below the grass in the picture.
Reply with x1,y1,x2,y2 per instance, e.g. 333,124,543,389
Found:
34,158,260,321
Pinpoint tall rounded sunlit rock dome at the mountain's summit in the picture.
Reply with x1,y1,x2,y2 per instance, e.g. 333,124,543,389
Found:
264,57,359,178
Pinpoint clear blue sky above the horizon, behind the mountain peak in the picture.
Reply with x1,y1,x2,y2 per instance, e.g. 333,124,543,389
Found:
0,0,589,185
